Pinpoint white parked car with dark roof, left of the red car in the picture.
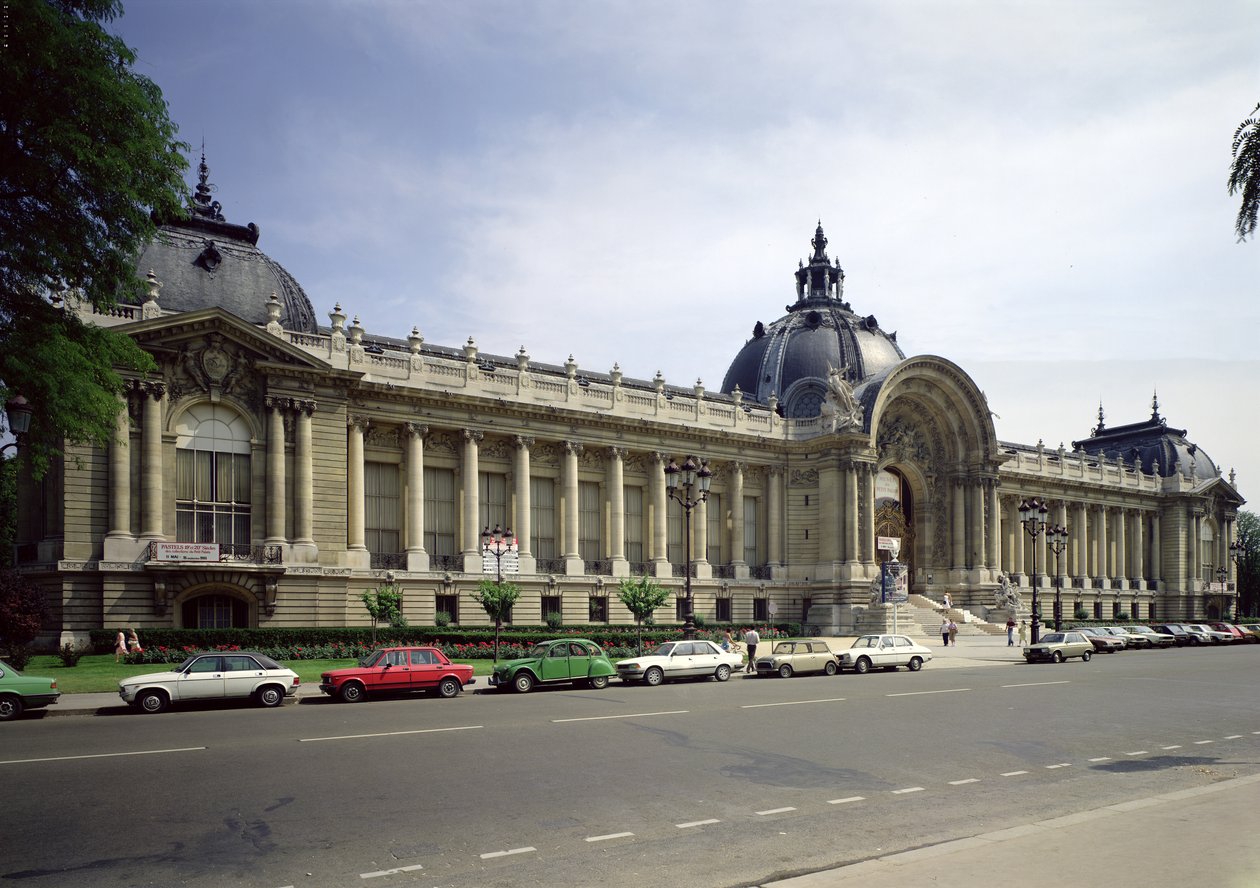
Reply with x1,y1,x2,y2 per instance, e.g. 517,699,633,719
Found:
118,651,301,713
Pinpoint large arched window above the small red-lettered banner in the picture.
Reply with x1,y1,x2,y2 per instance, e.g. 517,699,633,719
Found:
175,404,252,545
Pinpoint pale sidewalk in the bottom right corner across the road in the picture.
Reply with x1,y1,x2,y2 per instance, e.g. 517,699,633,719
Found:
761,775,1260,888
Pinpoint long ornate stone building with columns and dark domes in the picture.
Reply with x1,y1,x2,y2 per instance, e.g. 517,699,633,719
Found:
16,161,1242,641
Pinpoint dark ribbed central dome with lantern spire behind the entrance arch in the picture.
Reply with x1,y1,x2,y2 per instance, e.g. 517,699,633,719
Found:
722,222,906,417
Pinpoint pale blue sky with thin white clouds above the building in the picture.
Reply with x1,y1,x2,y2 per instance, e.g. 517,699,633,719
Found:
112,0,1260,509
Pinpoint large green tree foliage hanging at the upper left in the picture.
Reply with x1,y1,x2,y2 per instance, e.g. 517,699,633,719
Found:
0,0,188,474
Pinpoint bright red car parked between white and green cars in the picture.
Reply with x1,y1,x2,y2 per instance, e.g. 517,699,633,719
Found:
319,647,476,703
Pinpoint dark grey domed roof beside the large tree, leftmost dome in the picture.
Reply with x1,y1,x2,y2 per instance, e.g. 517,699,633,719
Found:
136,156,318,333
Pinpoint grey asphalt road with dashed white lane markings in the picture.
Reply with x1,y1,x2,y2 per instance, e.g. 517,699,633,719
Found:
0,646,1260,888
